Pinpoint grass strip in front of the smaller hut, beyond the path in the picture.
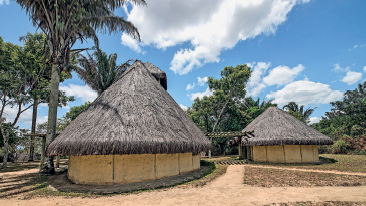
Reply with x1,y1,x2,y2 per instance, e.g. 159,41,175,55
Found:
252,154,366,173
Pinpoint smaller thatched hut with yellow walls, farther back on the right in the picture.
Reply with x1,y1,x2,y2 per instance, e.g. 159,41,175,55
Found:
228,107,333,163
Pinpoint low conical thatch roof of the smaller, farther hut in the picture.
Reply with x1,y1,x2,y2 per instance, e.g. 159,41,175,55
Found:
228,107,333,146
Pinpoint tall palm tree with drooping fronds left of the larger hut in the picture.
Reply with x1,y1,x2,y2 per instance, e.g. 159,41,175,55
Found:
16,0,146,173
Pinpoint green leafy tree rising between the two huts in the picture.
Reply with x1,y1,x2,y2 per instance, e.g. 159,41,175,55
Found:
186,65,275,155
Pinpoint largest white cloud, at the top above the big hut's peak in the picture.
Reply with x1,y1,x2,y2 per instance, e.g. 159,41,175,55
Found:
125,0,309,75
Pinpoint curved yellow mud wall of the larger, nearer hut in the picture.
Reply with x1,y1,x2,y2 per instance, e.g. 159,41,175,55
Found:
67,153,200,185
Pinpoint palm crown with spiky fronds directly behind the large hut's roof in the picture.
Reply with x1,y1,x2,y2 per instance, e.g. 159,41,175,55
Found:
76,49,132,96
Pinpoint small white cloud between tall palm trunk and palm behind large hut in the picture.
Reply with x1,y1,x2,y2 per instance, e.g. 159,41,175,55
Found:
60,84,98,102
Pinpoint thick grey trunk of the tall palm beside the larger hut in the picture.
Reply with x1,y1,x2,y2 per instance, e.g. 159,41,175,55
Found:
40,63,60,174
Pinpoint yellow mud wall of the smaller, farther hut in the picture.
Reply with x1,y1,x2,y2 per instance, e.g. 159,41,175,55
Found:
251,145,319,163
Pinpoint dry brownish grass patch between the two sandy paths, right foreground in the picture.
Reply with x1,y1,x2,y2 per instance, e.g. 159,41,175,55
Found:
244,167,366,187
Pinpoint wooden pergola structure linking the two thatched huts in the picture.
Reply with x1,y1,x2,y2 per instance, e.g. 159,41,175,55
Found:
203,131,254,159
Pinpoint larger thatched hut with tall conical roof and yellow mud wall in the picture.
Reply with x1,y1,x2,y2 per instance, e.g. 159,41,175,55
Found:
46,61,211,184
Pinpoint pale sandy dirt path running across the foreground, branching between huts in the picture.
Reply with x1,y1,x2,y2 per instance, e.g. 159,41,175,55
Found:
0,165,366,206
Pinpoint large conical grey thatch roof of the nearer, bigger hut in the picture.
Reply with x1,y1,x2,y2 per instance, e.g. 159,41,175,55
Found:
46,60,211,156
